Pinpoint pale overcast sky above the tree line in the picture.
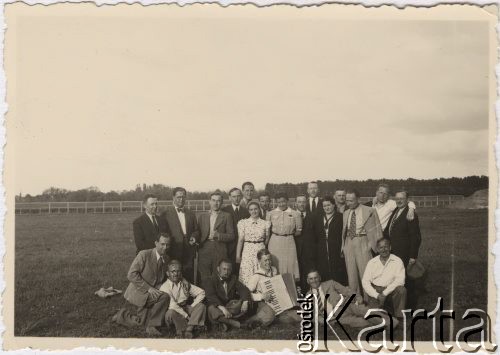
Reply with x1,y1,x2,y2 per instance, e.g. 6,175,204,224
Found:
7,4,493,194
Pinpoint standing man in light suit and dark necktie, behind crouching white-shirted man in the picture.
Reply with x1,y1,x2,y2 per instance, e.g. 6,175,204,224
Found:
342,190,383,293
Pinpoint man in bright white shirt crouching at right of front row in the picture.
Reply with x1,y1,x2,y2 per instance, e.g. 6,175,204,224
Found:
362,238,406,318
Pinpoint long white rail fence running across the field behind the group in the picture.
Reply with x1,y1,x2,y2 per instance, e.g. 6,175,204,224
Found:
15,195,464,214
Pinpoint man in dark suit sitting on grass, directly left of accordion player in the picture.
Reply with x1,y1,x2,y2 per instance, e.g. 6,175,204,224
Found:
203,259,252,331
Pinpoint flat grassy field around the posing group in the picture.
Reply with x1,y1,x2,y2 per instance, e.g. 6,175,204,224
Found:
15,209,488,340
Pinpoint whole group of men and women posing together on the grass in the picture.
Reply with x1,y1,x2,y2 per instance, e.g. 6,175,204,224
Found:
113,182,421,338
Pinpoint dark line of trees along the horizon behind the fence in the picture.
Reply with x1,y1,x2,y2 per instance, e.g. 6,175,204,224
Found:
16,175,489,202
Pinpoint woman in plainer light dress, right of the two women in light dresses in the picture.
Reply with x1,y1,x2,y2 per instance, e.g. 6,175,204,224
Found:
266,193,302,281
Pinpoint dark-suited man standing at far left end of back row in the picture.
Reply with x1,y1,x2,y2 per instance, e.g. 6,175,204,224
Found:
132,194,160,254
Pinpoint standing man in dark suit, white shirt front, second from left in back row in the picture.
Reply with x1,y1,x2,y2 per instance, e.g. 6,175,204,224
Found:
159,187,200,283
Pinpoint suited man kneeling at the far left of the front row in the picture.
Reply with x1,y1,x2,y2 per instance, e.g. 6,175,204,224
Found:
113,235,173,336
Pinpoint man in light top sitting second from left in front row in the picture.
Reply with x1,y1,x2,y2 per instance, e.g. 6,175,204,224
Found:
160,260,206,339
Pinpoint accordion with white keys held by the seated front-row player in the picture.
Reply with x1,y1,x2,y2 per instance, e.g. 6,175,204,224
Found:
260,274,297,315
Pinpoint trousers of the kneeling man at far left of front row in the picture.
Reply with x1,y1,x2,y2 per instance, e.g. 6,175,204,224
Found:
116,293,170,327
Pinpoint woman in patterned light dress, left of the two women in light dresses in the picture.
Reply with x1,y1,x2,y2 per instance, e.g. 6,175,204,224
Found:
236,202,271,287
